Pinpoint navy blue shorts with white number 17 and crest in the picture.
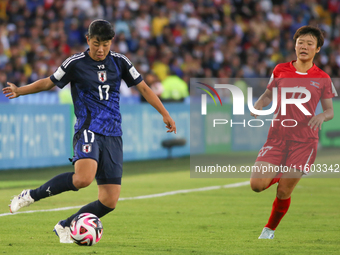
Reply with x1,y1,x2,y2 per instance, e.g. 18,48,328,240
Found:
72,129,123,185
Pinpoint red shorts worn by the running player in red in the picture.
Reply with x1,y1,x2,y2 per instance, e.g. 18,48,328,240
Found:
256,139,319,173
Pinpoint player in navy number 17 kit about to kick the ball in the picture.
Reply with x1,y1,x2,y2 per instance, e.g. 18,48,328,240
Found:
3,20,176,243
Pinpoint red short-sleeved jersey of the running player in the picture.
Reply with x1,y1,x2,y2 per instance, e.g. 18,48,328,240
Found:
267,61,337,142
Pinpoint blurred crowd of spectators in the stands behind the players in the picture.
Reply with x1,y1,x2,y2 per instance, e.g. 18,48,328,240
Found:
0,0,340,101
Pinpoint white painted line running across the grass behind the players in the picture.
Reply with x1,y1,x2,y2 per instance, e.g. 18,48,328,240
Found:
0,181,249,217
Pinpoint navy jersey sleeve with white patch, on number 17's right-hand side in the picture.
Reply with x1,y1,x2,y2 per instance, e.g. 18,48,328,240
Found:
116,53,143,87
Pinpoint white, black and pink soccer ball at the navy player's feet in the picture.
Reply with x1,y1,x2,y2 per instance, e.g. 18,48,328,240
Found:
70,213,103,246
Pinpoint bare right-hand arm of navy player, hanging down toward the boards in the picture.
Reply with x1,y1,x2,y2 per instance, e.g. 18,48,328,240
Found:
136,81,177,134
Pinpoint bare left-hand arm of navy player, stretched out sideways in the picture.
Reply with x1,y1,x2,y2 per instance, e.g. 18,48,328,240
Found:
2,77,54,99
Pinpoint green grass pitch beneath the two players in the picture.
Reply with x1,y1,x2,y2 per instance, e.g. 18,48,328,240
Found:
0,149,340,255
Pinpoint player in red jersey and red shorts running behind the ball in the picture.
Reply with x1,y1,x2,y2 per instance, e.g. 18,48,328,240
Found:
250,26,337,239
